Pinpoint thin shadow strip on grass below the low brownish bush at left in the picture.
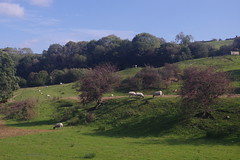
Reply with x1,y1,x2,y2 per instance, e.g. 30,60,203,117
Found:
7,120,55,127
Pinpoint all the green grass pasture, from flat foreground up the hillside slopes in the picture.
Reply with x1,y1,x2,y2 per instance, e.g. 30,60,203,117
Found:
0,56,240,160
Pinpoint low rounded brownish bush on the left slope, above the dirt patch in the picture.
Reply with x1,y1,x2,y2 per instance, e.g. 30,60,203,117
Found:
4,99,38,120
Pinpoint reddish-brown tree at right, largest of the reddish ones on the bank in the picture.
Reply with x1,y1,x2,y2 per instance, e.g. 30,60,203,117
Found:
180,67,231,118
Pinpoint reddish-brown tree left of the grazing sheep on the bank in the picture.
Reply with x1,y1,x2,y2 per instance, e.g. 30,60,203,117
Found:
79,64,119,103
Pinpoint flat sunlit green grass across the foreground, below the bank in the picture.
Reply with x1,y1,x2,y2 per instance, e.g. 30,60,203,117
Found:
0,127,240,160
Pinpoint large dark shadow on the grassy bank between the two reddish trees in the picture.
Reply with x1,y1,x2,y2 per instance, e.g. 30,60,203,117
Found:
85,111,181,138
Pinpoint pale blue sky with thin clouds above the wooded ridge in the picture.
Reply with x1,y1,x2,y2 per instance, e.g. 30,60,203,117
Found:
0,0,240,53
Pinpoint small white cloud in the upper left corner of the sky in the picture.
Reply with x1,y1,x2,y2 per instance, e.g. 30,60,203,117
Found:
0,2,24,17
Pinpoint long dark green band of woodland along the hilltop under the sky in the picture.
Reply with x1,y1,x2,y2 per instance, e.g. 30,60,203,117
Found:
1,32,240,87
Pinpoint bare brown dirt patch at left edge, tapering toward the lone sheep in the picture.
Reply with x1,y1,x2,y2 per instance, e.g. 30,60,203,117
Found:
0,119,50,139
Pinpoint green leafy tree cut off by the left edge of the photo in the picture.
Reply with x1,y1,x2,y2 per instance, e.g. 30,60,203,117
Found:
0,50,18,103
